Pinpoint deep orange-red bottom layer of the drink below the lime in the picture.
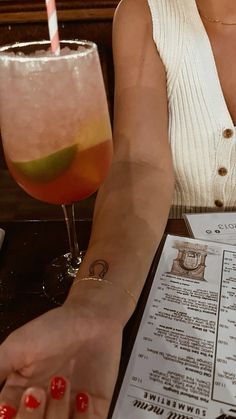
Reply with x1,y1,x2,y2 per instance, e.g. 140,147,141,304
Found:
6,140,112,204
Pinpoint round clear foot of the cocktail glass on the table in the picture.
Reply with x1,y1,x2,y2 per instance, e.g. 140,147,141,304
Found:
42,252,84,305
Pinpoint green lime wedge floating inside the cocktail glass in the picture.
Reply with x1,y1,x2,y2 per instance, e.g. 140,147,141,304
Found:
12,144,77,182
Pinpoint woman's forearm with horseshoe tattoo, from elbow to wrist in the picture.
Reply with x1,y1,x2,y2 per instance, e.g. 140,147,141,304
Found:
66,162,173,323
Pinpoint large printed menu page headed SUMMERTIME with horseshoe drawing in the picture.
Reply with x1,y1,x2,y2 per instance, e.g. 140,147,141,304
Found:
112,236,236,419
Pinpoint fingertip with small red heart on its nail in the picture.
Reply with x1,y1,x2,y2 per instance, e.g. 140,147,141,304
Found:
14,387,46,419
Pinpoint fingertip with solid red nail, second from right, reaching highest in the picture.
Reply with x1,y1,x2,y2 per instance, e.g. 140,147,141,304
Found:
46,376,70,419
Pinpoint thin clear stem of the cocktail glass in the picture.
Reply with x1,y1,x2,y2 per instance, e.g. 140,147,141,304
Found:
62,204,82,270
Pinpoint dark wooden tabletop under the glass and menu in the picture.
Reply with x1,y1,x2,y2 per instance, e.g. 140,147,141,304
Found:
0,220,188,411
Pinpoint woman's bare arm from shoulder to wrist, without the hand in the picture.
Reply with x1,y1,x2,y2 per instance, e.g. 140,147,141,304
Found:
69,0,173,323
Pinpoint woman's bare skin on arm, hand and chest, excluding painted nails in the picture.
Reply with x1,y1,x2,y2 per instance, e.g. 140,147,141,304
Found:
0,0,236,419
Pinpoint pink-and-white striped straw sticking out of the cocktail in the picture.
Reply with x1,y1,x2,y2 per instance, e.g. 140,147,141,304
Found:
46,0,60,55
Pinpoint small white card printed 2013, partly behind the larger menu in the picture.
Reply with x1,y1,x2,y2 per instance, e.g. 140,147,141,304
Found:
184,212,236,245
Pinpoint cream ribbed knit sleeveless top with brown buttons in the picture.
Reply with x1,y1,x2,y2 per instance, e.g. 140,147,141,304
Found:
148,0,236,218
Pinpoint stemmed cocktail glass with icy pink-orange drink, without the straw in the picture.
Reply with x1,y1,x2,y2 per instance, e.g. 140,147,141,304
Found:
0,41,112,302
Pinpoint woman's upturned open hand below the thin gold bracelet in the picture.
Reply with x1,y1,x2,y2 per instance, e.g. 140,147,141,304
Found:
0,290,123,419
